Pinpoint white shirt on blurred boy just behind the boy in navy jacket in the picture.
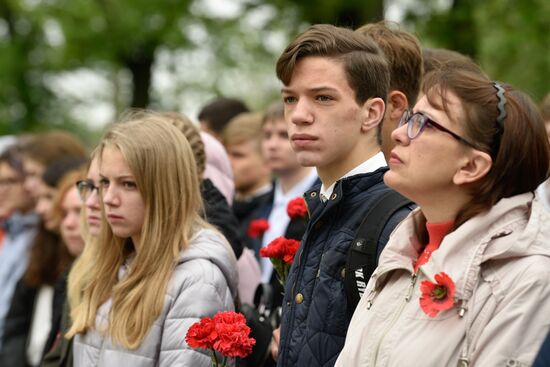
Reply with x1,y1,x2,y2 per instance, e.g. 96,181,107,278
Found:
260,168,318,283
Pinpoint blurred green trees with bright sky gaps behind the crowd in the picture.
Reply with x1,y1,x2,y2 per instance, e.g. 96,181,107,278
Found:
0,0,550,136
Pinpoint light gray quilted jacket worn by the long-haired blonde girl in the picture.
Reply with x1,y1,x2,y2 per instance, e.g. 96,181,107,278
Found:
74,229,237,367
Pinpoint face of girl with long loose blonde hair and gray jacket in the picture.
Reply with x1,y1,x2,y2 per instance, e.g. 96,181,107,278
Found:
99,146,145,245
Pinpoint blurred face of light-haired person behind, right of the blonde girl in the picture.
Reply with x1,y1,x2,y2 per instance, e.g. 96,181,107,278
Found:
226,141,270,194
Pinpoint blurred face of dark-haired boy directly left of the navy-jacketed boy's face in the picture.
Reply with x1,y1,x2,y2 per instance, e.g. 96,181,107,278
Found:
262,119,301,174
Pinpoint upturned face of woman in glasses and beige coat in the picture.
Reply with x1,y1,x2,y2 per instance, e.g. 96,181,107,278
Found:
384,92,470,205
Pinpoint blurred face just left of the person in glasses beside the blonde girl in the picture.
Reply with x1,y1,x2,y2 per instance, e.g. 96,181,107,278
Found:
60,187,84,257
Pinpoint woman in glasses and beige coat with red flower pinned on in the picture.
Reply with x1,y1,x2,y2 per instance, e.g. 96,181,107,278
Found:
336,68,550,367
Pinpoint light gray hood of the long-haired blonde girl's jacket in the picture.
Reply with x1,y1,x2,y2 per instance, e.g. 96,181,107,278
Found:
178,228,238,296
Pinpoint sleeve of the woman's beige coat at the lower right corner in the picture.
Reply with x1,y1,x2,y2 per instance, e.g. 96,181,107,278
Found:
472,269,550,366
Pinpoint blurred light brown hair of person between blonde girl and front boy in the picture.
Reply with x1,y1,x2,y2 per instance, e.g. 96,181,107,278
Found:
222,112,263,153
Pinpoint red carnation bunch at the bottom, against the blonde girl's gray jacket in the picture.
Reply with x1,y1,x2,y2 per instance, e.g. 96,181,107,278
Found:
185,311,256,366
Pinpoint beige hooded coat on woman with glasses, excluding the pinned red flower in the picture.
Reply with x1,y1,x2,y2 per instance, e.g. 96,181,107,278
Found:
336,193,550,367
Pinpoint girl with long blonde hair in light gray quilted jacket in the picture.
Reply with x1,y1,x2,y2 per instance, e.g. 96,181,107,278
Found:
67,114,237,367
